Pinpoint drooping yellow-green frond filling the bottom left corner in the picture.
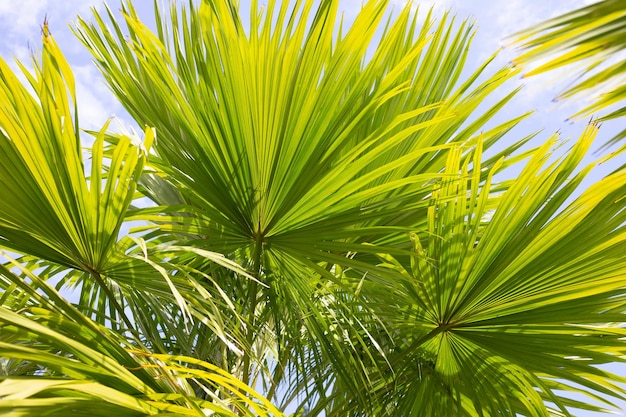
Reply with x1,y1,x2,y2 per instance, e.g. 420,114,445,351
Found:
0,262,282,417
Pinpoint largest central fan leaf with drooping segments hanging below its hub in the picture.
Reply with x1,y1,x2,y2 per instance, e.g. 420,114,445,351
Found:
76,1,522,410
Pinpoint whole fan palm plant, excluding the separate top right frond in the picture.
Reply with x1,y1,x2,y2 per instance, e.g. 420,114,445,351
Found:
0,0,626,416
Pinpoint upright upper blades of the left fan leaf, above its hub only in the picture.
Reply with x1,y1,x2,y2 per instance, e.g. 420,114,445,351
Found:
0,35,151,272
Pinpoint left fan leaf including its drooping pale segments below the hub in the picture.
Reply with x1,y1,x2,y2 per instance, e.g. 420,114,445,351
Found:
0,26,258,374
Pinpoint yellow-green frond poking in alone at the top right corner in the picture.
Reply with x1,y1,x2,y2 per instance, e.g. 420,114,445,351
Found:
514,0,626,144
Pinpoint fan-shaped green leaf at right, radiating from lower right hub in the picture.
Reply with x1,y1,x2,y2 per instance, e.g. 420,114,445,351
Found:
372,125,626,416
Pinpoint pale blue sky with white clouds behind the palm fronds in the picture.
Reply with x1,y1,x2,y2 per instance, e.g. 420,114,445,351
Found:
0,0,626,417
